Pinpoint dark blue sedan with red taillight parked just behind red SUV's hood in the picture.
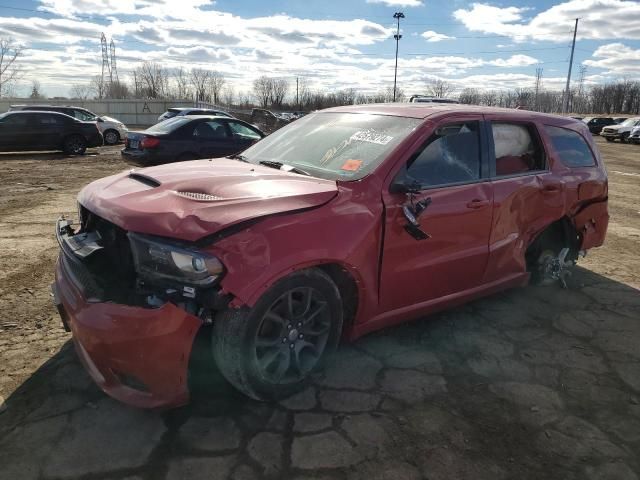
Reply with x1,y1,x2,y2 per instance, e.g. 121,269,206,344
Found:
122,115,264,165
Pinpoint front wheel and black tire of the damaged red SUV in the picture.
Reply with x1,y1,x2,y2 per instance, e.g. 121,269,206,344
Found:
212,268,342,400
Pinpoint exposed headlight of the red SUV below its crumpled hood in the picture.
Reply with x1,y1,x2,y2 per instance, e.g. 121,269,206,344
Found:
128,233,224,286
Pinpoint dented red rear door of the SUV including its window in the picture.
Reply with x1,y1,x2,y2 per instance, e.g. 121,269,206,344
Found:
484,115,565,282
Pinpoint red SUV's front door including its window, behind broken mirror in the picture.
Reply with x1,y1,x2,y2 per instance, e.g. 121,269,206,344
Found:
380,115,493,311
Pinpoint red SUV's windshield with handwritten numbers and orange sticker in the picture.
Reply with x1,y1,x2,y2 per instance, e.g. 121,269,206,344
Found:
242,113,421,180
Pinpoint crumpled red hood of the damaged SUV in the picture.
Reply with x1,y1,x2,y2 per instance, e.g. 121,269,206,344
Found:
78,158,338,241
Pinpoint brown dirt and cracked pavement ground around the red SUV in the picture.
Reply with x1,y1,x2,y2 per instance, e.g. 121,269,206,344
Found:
0,139,640,480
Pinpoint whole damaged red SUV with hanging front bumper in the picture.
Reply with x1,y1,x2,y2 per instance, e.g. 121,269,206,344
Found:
53,104,608,407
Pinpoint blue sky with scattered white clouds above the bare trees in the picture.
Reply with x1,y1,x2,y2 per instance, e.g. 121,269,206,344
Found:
0,0,640,96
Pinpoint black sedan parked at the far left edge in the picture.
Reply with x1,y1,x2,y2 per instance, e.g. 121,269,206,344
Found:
0,111,102,155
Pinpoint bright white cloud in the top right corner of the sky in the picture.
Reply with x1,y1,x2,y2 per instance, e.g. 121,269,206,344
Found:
453,0,640,42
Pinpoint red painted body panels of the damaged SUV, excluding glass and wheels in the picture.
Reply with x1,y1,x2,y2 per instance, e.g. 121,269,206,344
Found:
57,104,608,406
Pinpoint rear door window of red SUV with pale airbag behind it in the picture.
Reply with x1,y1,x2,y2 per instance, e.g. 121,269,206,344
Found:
491,122,546,177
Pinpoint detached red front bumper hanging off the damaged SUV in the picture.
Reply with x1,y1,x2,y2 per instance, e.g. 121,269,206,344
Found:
52,234,202,408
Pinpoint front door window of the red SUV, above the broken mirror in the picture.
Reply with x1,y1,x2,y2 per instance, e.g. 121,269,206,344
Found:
406,122,480,187
